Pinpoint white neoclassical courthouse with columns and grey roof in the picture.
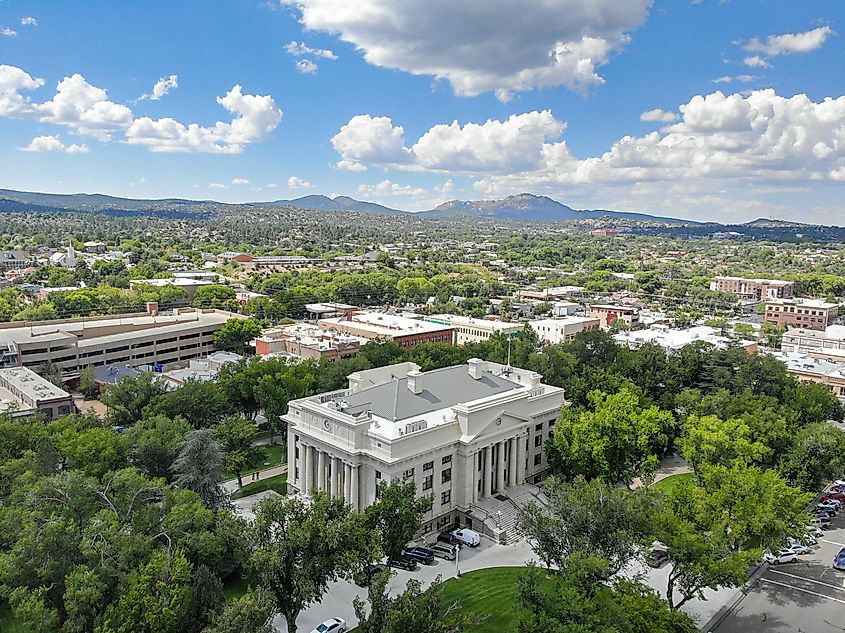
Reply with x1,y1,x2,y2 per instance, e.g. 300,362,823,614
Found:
285,359,565,533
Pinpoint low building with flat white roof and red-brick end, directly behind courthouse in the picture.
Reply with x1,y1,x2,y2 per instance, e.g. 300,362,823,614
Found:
317,312,454,349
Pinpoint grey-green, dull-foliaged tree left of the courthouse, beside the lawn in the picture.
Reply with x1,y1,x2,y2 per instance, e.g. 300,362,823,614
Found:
173,429,224,508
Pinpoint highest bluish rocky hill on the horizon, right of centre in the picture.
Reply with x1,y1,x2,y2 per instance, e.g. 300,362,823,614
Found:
422,193,697,224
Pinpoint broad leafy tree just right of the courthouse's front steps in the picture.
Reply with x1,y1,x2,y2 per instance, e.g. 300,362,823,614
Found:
518,477,656,578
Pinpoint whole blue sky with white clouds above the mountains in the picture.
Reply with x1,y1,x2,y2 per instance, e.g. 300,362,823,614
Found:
0,0,845,224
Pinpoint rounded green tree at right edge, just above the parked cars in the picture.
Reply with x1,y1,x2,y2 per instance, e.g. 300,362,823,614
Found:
778,422,845,492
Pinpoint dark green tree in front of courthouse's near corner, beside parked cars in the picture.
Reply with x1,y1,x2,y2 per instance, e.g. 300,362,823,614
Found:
364,480,431,560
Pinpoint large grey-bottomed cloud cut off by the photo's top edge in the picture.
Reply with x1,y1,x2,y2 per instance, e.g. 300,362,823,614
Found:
282,0,653,100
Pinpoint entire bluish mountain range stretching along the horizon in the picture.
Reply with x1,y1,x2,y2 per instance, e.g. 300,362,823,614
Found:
0,189,824,226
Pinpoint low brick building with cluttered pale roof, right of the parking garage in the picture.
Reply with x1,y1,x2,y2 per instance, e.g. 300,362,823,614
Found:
255,323,369,361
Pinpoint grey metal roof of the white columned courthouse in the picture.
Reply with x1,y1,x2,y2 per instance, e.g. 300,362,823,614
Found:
335,365,525,422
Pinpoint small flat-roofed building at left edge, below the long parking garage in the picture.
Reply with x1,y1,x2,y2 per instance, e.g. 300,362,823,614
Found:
0,367,75,420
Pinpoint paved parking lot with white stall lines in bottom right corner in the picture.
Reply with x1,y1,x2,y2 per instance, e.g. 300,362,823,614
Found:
709,494,845,633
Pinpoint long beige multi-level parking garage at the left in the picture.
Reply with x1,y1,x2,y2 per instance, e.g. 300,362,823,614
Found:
0,303,244,377
